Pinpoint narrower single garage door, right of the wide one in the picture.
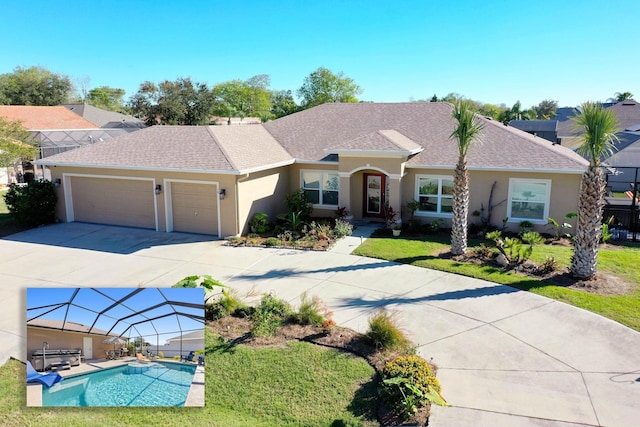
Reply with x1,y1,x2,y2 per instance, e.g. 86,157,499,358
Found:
171,182,218,235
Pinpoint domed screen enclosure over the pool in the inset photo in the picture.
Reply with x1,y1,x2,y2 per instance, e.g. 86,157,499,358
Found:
26,288,204,362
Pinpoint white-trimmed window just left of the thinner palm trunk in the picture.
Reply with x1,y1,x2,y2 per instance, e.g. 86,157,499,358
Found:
416,175,453,215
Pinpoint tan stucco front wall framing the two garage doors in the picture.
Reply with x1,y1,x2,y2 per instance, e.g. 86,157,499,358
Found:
50,166,238,236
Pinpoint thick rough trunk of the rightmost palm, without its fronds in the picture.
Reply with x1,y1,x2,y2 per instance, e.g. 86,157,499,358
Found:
571,165,606,279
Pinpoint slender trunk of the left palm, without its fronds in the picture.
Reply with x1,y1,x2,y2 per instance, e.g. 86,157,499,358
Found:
451,157,469,255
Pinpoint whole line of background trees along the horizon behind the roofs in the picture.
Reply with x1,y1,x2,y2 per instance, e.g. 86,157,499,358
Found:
0,67,633,125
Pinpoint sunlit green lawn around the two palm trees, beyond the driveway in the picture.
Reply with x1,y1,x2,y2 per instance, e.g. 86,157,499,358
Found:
354,236,640,331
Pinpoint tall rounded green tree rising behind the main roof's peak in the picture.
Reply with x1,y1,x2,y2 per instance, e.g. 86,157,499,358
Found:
297,67,362,109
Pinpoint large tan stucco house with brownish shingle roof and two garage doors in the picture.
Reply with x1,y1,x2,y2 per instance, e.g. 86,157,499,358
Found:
37,103,587,237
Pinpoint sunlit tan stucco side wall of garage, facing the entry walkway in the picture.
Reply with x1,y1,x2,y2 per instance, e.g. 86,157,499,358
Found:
236,167,290,234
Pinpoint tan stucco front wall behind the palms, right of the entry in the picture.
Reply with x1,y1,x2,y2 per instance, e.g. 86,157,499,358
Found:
402,168,580,232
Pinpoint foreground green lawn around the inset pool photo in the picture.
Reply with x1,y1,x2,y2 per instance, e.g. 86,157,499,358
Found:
0,329,378,427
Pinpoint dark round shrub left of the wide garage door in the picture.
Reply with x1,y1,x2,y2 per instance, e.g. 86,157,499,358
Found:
4,180,57,227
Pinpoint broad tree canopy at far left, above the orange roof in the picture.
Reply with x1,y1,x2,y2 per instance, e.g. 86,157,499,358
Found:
0,67,73,105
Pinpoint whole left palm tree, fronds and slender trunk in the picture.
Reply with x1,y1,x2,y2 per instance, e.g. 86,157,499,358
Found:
449,100,484,255
